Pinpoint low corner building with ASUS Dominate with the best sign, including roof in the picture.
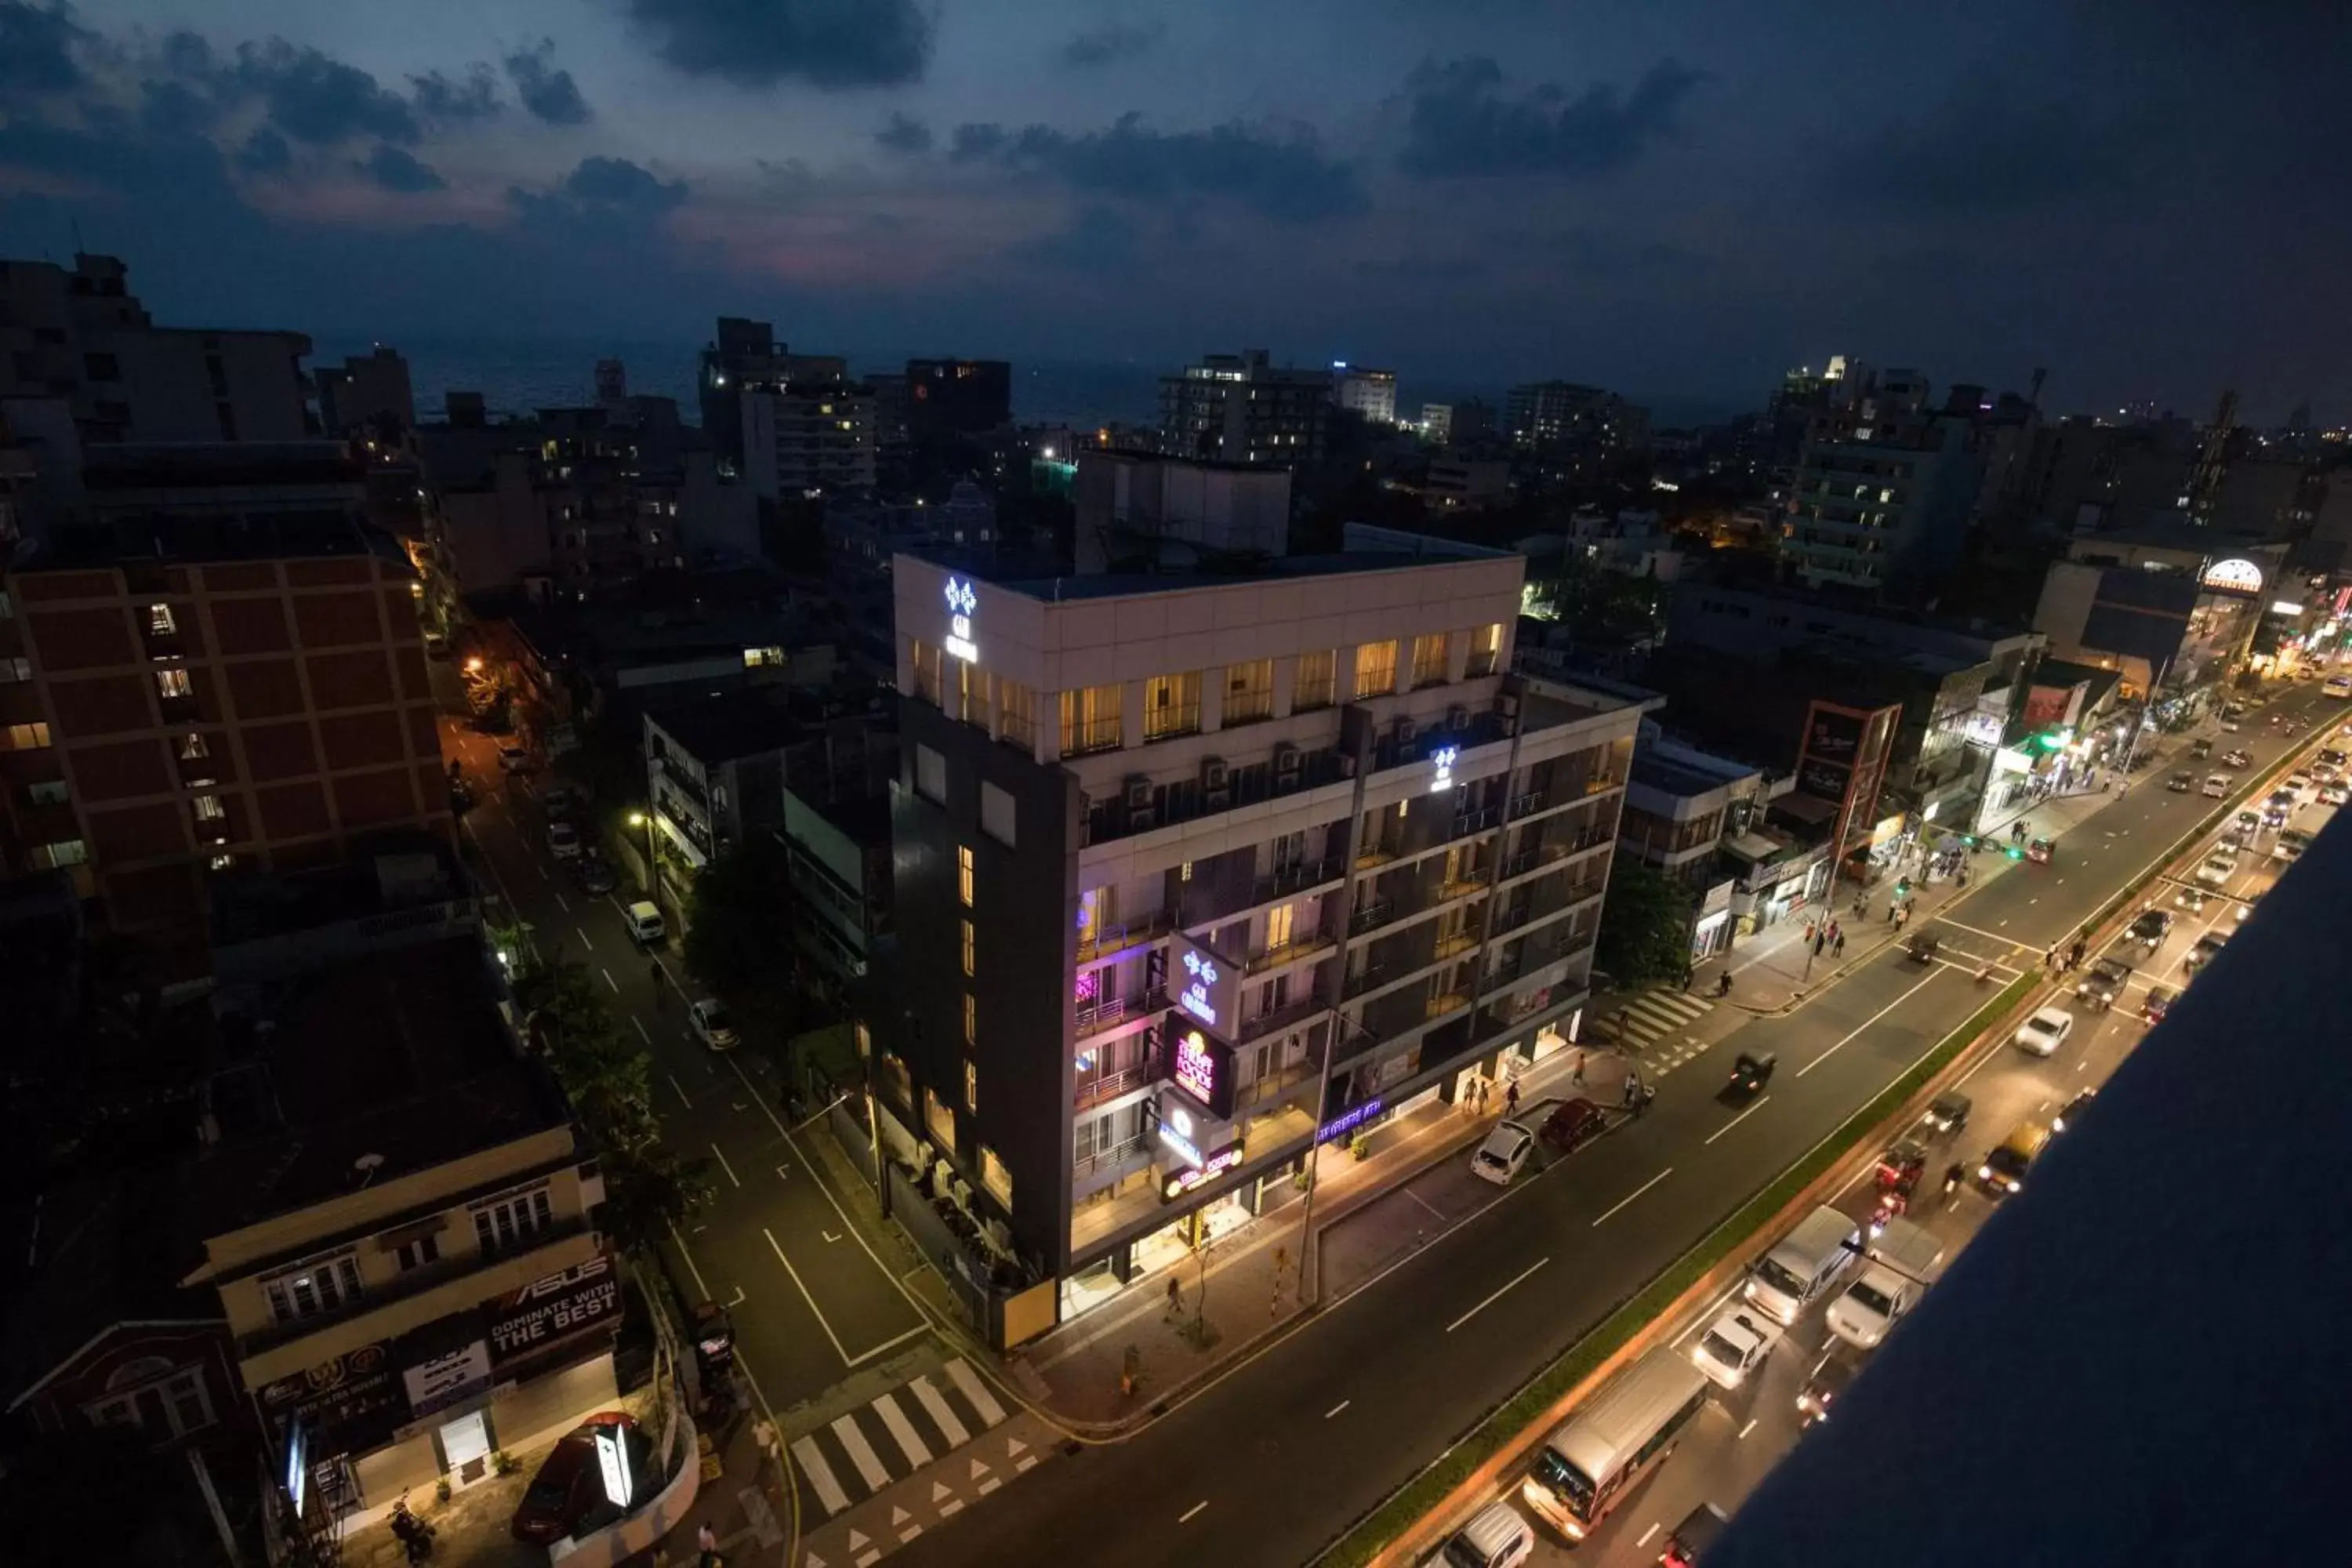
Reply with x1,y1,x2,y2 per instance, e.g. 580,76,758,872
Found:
181,931,621,1530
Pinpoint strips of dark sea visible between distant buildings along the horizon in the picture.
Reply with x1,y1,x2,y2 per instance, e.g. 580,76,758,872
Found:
310,339,1738,428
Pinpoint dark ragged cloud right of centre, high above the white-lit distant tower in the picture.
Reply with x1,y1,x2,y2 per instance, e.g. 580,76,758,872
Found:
1397,56,1708,176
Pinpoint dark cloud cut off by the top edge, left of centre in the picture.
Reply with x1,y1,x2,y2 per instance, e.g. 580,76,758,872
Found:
628,0,934,87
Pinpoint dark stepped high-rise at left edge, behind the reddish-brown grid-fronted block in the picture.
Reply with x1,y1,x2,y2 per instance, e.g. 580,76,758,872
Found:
0,256,318,445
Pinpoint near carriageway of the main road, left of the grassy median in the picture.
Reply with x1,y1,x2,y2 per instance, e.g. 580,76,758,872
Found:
877,689,2343,1566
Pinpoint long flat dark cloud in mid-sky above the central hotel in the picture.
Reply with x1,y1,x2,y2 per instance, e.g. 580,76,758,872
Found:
953,113,1367,221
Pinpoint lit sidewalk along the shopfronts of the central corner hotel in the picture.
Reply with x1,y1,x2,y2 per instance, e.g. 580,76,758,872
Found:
1007,1046,1628,1427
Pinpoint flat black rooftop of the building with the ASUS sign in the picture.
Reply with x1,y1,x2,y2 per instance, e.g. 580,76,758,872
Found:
181,933,569,1239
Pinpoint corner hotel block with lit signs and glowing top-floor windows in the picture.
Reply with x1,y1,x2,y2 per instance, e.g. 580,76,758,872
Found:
873,536,1642,1316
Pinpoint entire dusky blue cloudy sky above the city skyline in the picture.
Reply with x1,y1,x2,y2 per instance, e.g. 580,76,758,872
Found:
0,0,2352,421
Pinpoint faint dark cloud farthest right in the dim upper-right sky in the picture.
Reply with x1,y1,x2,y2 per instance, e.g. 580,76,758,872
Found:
1823,73,2161,214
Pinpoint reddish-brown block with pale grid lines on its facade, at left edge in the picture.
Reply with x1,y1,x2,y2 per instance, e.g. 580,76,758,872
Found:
0,445,449,940
